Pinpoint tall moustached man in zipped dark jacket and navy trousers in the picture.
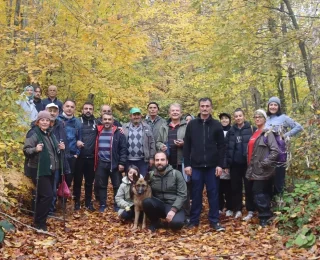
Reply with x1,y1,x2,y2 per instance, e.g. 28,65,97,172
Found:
183,98,225,231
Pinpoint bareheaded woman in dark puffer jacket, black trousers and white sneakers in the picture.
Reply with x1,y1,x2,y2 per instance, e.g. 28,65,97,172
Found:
226,108,256,221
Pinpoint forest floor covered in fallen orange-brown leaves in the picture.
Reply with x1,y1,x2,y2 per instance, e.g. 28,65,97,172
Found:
0,187,320,260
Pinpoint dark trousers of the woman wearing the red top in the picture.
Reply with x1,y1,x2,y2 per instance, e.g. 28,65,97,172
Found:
249,180,272,219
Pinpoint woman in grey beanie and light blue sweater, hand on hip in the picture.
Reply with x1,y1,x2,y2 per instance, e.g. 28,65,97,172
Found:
265,97,303,196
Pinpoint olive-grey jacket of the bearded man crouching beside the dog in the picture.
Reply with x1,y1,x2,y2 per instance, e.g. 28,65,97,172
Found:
150,165,187,211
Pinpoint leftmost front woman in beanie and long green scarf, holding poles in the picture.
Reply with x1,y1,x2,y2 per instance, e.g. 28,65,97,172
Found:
23,111,65,231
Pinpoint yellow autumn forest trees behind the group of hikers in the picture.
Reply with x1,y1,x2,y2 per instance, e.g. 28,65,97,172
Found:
0,0,320,256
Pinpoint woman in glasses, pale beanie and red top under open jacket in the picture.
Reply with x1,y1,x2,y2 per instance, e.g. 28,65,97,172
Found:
246,109,279,227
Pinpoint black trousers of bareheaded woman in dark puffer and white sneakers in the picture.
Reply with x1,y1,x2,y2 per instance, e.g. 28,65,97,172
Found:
230,164,254,211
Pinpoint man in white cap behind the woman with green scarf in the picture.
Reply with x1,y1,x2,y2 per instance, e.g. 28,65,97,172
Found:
46,103,70,214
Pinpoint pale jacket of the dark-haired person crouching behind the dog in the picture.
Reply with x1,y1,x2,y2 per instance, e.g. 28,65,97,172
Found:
115,175,143,216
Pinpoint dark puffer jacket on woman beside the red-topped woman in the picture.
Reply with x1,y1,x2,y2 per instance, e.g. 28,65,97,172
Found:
225,121,257,168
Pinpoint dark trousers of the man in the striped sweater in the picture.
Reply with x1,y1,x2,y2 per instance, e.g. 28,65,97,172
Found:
95,160,120,206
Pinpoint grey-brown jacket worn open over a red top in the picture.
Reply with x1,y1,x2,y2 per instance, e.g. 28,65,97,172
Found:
246,130,279,180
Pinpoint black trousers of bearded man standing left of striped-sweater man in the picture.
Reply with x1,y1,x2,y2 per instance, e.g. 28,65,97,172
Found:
73,158,94,205
